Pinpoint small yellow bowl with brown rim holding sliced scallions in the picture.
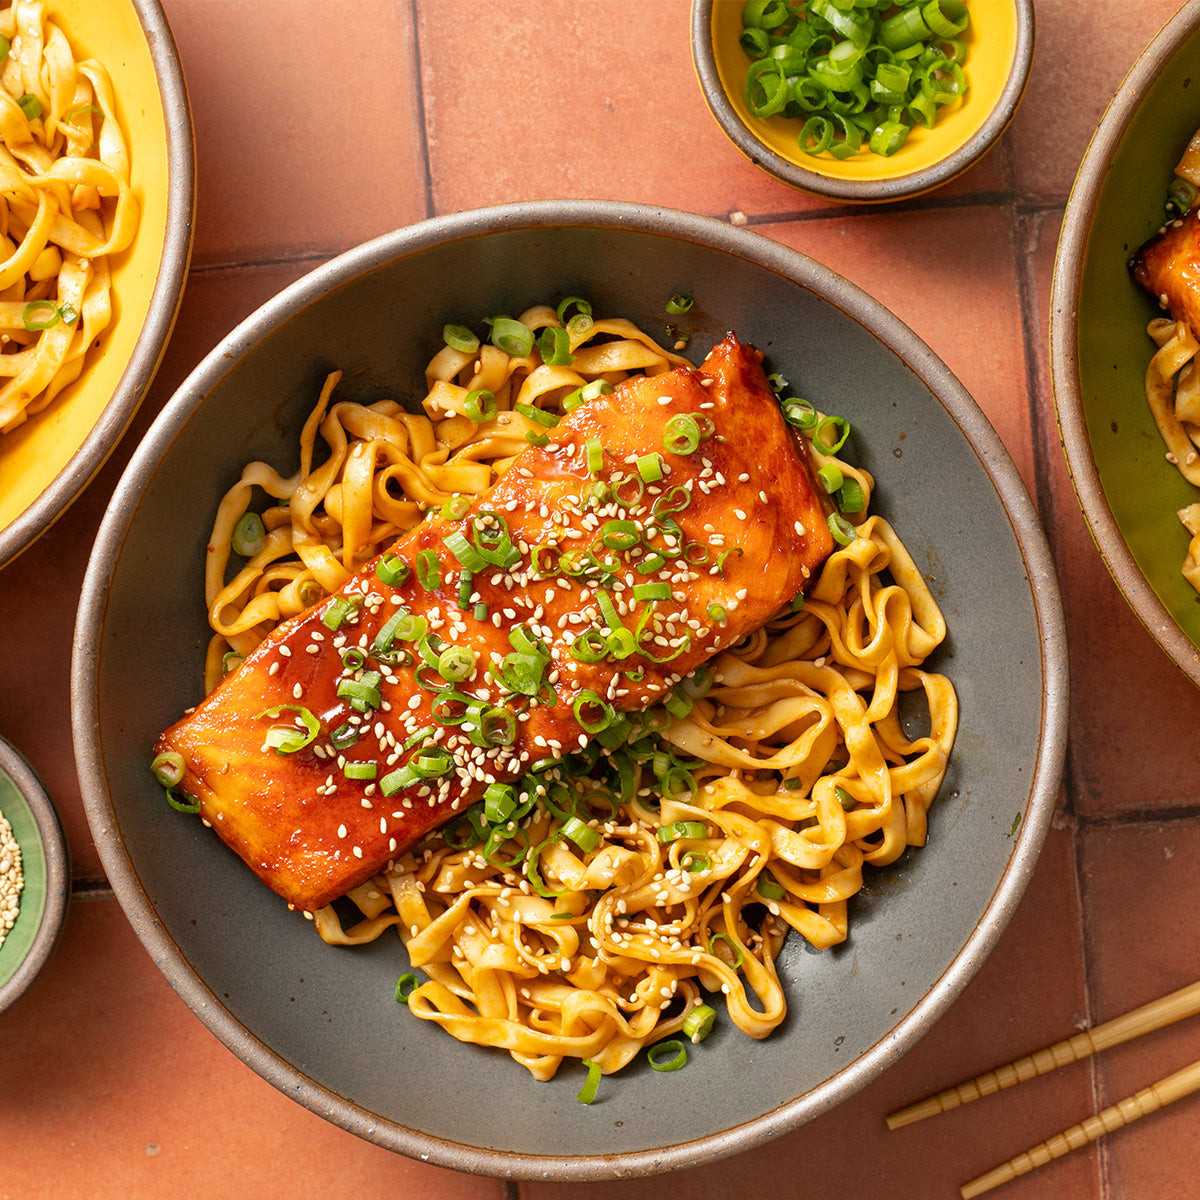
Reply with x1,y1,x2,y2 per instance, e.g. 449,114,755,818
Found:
691,0,1033,204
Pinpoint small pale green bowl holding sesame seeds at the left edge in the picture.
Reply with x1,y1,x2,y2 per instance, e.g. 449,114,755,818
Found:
0,738,71,1013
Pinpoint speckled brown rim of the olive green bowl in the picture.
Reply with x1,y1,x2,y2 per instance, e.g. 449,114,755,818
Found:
1050,2,1200,686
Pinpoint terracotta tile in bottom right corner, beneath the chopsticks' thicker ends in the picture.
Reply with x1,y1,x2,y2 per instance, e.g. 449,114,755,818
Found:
1081,817,1200,1200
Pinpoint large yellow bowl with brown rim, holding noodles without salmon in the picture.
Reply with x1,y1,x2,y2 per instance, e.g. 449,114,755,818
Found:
0,0,194,566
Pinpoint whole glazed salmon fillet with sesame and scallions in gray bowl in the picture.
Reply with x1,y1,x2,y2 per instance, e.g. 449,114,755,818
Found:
156,334,833,911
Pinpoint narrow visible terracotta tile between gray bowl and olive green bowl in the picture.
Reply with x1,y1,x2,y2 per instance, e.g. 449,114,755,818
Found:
1026,212,1200,816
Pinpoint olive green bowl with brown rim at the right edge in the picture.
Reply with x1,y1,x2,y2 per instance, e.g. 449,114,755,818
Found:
1050,2,1200,686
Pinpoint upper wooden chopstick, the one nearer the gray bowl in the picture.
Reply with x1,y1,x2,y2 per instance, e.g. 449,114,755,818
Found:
887,982,1200,1129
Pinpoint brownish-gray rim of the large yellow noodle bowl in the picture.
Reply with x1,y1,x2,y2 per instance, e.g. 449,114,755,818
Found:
0,0,196,568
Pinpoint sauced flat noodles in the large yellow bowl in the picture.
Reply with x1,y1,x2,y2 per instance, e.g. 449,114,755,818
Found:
0,0,139,433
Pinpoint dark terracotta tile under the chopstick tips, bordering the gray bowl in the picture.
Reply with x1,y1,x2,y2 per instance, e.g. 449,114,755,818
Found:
522,830,1098,1200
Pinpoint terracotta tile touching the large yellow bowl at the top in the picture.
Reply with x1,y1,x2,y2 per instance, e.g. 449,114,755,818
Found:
163,0,427,264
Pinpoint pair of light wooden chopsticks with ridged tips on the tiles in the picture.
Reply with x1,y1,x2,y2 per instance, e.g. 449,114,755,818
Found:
887,982,1200,1200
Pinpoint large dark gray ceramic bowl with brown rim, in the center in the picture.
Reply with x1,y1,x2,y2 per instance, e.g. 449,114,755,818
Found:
73,202,1067,1180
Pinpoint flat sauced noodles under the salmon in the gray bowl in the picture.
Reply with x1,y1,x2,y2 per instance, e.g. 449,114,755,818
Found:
206,302,956,1098
